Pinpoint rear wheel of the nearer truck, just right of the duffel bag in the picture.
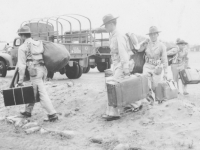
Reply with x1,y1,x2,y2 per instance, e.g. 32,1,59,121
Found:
65,62,79,79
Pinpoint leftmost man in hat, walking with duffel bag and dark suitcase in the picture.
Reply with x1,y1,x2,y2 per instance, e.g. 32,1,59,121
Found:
17,26,58,122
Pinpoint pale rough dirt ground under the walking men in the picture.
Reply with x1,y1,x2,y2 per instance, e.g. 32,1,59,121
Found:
0,52,200,150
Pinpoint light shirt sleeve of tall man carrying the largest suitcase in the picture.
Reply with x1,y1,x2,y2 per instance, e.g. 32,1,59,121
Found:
117,36,130,69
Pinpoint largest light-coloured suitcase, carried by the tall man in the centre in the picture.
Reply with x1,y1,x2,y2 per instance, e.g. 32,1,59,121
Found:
106,75,149,107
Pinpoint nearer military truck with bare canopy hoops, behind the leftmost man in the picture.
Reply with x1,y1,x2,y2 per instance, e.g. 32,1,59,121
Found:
13,14,95,79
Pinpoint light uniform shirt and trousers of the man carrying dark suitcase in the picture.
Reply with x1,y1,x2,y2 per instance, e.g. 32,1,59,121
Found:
17,38,56,115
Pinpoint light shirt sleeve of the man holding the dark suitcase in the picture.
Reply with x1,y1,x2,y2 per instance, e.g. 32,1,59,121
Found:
17,47,26,83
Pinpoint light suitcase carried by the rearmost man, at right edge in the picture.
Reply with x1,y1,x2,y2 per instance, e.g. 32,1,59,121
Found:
179,69,200,84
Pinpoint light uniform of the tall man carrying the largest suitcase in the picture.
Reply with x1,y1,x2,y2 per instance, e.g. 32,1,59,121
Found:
106,30,133,116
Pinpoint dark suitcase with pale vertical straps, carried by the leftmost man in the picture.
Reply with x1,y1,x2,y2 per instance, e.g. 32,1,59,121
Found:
3,86,39,106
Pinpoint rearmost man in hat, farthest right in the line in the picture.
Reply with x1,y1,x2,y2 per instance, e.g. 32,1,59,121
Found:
167,39,189,95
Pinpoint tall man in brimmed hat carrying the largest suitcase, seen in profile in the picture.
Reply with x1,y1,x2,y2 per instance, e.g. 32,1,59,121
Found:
102,14,132,121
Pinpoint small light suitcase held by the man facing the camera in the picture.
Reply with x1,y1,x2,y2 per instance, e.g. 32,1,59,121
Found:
155,81,178,101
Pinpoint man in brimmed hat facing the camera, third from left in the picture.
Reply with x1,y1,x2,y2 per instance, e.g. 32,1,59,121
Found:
143,26,168,103
